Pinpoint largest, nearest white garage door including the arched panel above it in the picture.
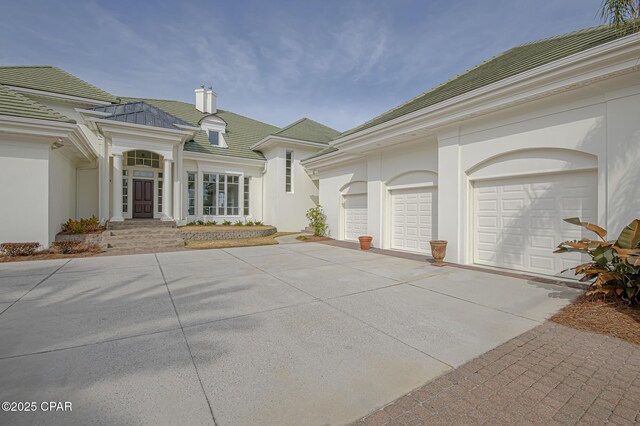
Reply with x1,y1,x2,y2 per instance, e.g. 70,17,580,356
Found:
468,149,598,275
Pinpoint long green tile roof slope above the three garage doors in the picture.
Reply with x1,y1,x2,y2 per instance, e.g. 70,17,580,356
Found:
340,24,638,136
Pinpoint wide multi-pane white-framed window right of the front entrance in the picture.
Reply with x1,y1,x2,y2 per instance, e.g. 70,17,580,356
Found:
202,173,240,216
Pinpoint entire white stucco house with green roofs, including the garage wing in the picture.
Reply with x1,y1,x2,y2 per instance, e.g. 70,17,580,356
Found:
0,22,640,275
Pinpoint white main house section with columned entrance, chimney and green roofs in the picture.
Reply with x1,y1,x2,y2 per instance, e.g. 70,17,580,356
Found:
0,66,339,246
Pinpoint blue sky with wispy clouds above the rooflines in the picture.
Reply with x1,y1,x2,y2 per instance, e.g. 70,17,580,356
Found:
0,0,601,130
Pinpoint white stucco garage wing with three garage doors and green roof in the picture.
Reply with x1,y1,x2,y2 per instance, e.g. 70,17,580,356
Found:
303,26,640,275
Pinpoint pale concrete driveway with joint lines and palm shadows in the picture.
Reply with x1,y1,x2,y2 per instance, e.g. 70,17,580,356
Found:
0,243,577,425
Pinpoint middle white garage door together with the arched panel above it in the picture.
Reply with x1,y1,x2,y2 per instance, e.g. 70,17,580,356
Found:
386,170,438,254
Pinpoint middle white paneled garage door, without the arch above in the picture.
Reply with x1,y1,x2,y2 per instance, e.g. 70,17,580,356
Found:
391,188,438,254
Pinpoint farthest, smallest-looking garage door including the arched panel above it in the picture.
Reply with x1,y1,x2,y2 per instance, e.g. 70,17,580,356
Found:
340,181,368,241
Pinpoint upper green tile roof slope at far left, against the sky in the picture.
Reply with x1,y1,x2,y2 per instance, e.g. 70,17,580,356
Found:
0,65,118,102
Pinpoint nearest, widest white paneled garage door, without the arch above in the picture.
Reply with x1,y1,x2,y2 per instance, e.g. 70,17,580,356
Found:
474,171,598,275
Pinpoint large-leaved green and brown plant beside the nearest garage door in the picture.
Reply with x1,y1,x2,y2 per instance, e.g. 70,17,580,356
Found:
554,217,640,305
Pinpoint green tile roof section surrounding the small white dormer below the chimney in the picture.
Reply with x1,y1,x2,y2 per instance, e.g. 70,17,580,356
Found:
121,97,280,160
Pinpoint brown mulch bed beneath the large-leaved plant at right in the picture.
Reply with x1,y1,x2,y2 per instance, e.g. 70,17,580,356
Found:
551,295,640,345
